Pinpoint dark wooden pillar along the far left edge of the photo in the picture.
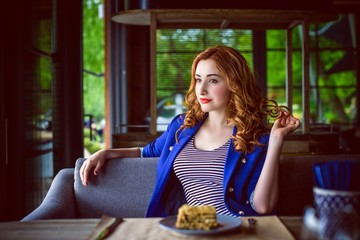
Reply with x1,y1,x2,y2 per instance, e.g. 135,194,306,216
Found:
0,2,27,221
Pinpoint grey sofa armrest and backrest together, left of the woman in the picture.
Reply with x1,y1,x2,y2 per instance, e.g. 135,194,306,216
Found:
22,158,158,221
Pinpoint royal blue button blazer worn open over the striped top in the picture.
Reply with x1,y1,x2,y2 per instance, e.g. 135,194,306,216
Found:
143,115,269,217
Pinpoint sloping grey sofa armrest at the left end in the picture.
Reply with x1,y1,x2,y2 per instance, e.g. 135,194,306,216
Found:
21,168,75,221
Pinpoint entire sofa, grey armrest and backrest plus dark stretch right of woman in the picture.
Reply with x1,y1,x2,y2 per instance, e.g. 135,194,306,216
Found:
21,155,360,221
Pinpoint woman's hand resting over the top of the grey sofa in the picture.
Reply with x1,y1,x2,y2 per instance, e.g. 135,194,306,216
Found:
80,149,106,186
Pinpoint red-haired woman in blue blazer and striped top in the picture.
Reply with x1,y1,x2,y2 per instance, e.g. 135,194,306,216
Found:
80,46,300,217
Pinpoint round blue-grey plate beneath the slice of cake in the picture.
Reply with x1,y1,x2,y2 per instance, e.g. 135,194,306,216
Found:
159,214,241,235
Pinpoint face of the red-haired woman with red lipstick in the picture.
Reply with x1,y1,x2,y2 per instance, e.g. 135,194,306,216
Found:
195,59,229,112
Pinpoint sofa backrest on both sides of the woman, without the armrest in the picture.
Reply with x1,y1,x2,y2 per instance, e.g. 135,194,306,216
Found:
74,155,360,218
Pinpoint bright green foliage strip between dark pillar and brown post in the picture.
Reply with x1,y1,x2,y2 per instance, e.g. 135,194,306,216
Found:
83,0,105,153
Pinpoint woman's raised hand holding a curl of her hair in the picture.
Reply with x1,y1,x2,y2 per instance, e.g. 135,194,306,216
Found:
271,111,300,137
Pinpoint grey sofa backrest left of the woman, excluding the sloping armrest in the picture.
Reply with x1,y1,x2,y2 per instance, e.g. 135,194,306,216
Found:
74,158,158,218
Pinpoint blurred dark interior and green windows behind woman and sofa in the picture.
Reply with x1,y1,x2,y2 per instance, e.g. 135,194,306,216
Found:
0,0,360,221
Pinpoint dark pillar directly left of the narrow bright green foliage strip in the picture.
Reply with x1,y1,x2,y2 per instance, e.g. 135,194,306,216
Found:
53,0,84,173
